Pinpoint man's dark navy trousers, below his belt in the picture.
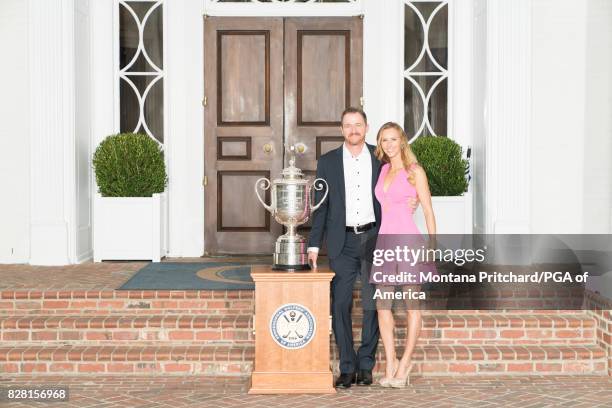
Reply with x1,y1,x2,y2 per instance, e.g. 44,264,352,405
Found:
329,228,379,373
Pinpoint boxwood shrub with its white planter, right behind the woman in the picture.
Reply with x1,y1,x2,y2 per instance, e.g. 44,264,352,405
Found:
411,136,472,234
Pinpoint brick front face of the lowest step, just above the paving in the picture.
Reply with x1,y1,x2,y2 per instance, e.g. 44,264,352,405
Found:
0,348,608,378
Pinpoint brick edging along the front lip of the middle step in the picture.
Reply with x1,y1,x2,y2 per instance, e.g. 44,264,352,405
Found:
0,313,596,330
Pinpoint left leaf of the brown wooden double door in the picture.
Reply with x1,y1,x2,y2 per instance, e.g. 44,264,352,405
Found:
204,17,283,254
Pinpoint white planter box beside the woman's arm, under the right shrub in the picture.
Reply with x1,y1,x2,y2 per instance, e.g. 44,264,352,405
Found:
415,193,472,234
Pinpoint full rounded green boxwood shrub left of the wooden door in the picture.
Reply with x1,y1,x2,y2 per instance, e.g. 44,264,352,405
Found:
93,133,168,197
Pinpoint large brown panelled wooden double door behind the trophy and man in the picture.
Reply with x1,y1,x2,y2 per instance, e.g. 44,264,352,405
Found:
204,17,363,255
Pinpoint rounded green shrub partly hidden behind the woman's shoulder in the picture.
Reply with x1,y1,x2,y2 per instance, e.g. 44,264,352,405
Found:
410,136,469,196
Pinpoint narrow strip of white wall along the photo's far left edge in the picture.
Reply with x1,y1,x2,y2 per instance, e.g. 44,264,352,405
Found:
0,0,30,263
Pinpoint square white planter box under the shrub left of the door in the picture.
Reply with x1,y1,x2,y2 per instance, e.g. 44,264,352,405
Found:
93,193,167,262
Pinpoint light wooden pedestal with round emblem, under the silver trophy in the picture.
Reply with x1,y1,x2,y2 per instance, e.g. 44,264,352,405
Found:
249,266,336,394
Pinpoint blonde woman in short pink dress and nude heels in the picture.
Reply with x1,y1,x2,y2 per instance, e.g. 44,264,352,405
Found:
370,122,436,388
